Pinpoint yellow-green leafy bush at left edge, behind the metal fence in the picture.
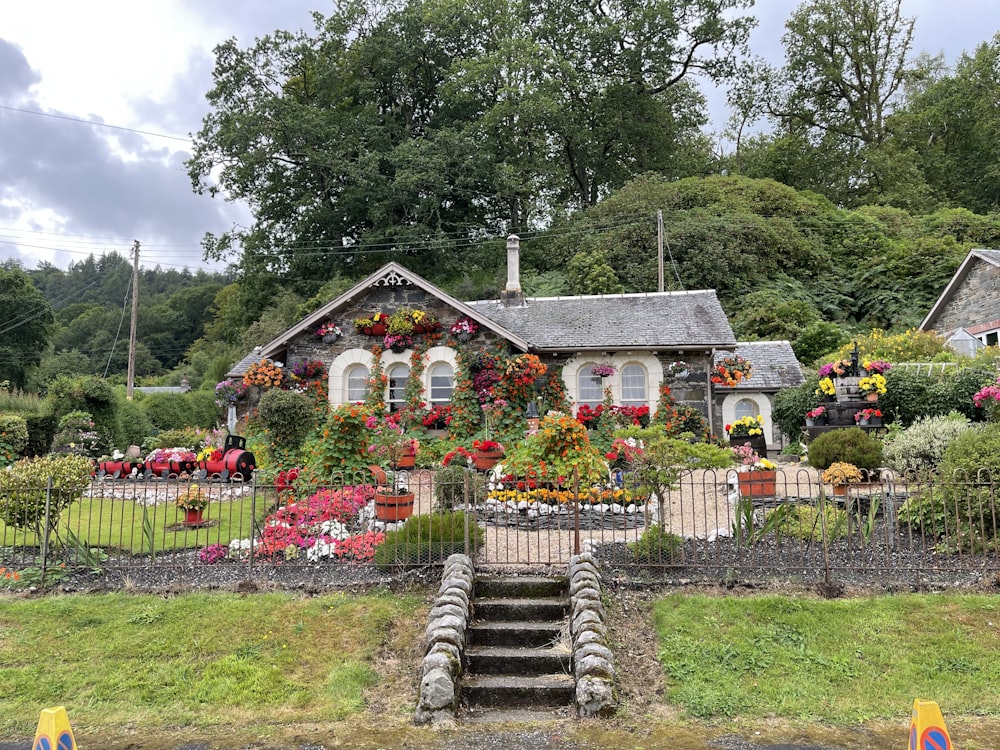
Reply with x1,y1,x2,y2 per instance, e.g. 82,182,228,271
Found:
0,455,94,539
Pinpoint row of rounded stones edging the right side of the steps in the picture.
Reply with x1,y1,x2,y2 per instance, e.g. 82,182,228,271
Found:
569,552,618,718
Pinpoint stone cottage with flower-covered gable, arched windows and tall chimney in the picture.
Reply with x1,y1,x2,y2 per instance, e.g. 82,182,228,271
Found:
229,236,801,434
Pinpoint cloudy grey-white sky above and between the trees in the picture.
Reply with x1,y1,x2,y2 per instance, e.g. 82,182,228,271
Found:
0,0,1000,271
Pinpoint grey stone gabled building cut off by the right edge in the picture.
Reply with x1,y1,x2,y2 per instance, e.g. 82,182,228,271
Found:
919,250,1000,356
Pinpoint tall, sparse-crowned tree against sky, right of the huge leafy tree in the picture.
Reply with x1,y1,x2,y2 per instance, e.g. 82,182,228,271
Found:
744,0,926,205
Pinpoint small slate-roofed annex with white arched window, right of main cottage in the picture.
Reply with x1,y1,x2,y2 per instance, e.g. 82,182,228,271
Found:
715,341,806,448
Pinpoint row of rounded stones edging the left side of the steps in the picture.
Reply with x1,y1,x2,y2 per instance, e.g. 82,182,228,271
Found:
413,554,476,724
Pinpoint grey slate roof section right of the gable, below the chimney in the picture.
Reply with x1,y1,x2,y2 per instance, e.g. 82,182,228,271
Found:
468,290,736,351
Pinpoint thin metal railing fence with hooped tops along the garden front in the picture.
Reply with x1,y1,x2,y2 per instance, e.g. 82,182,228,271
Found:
0,467,1000,586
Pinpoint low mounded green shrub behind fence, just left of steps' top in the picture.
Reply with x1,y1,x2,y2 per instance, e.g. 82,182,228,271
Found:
374,511,486,566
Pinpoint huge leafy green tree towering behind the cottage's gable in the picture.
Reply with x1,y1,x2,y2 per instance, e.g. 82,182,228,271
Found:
189,0,751,312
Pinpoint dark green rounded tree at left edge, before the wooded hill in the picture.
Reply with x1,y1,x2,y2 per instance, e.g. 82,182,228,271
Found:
0,263,55,388
